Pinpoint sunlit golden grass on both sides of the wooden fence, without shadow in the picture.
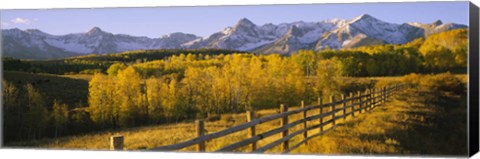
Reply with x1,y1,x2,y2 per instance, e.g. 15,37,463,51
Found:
13,75,466,154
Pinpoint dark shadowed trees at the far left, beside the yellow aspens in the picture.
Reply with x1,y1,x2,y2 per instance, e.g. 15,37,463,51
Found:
2,80,97,143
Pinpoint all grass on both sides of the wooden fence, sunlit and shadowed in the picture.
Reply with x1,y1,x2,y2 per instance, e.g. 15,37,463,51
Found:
5,75,466,155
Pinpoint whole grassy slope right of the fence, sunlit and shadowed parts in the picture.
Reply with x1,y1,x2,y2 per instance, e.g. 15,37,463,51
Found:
293,76,467,155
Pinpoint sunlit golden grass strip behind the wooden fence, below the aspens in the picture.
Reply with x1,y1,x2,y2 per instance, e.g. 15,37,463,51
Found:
14,100,358,153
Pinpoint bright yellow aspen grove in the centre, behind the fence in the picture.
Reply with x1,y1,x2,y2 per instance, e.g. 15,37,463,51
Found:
88,54,342,127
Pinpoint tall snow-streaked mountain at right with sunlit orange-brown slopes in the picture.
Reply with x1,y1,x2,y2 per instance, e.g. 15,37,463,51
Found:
315,14,467,50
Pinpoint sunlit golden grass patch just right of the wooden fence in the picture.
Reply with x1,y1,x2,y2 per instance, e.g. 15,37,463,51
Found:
292,94,416,154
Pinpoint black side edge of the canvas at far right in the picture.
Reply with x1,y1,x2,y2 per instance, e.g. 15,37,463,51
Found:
468,2,479,156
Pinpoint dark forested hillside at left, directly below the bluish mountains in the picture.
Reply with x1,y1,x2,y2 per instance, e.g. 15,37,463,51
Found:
2,49,244,75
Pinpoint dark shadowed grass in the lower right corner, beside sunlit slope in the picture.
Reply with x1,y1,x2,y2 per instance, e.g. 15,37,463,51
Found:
361,90,467,155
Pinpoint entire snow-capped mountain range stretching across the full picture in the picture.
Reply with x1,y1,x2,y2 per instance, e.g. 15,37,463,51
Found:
2,14,467,59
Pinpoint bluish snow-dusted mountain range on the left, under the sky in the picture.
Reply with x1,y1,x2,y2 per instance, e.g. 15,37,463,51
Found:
2,27,199,59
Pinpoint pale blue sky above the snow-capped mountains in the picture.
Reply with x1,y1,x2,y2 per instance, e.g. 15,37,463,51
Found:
0,2,468,38
